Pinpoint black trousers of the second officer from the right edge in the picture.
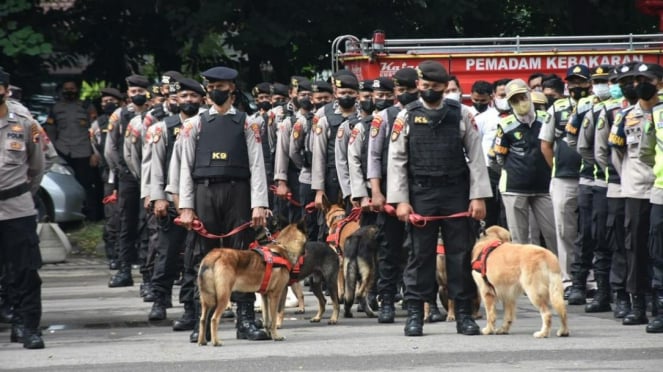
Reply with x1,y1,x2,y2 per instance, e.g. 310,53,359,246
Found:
625,198,651,294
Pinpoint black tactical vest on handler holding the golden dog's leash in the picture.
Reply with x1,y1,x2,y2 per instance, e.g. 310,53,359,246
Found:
407,100,469,177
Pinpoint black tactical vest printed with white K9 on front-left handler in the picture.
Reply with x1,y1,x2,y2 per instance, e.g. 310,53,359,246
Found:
193,110,251,180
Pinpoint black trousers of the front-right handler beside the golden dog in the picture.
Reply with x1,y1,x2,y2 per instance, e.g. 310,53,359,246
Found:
403,175,477,301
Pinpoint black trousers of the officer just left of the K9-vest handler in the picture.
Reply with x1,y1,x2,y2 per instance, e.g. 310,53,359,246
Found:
151,203,189,300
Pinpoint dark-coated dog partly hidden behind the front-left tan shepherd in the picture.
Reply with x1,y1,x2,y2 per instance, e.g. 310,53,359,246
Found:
277,242,340,328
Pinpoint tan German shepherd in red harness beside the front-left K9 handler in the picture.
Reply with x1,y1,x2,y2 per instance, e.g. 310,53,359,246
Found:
198,222,306,346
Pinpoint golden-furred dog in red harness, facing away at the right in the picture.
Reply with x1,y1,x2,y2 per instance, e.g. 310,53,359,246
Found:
472,226,569,338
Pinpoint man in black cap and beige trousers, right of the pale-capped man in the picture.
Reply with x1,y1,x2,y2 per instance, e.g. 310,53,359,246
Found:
539,65,591,290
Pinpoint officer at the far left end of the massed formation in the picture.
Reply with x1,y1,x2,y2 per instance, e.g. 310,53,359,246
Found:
90,88,123,270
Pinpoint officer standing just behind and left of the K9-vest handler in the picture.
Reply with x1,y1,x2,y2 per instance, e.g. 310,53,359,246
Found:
144,77,205,324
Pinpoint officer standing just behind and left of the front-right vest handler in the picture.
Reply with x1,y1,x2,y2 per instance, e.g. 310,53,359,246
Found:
366,67,419,323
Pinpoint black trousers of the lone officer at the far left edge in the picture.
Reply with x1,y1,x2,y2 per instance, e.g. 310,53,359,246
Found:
0,216,42,329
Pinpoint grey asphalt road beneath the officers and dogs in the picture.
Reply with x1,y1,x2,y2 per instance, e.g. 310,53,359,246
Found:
0,258,663,372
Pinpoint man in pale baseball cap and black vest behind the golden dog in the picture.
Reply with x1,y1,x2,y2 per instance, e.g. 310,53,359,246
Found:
493,79,557,247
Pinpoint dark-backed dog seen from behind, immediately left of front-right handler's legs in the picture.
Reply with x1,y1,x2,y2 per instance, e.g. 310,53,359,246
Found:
343,225,378,318
